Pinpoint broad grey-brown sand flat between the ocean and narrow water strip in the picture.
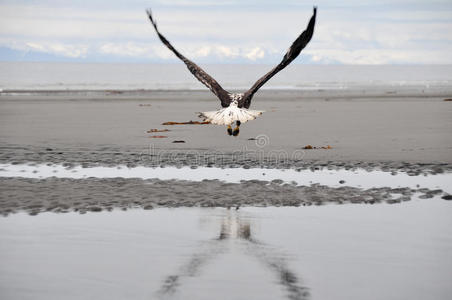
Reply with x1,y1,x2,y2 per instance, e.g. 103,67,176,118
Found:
0,91,452,167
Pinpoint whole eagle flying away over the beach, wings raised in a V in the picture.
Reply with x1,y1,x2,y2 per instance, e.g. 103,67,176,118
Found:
147,7,317,136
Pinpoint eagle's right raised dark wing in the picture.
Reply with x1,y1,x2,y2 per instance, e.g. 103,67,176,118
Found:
239,7,317,108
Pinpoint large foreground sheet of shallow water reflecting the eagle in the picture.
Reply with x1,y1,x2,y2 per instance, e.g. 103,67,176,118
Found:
0,198,452,299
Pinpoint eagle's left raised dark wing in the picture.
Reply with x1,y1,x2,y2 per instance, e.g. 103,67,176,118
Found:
146,9,231,107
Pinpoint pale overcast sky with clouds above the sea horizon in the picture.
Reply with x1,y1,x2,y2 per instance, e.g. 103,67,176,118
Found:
0,0,452,64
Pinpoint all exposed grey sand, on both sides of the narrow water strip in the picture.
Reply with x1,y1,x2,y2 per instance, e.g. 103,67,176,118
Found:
0,91,452,215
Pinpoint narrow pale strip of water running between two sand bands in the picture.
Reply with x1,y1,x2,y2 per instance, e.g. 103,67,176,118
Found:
0,164,452,193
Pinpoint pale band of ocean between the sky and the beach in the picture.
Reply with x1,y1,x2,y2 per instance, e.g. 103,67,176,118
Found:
0,62,452,91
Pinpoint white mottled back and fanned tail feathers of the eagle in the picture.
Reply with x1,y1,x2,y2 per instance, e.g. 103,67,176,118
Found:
199,94,264,125
